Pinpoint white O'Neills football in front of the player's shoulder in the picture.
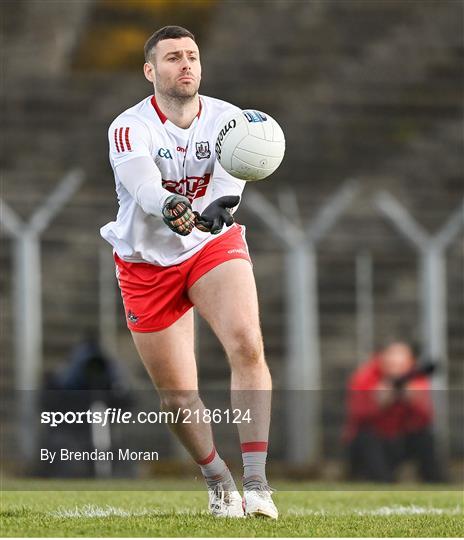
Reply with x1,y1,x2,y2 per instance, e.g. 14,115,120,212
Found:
216,109,285,182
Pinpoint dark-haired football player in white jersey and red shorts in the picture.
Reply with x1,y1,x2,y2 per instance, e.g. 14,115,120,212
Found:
101,26,278,518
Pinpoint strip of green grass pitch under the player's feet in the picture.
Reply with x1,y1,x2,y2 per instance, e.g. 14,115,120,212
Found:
0,481,464,537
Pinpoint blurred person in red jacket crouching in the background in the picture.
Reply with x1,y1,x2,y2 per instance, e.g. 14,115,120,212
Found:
345,342,442,482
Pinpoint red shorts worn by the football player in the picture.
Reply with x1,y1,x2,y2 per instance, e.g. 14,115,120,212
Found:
114,224,251,332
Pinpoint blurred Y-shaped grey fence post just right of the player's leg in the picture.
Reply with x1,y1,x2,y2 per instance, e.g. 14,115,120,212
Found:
244,181,358,467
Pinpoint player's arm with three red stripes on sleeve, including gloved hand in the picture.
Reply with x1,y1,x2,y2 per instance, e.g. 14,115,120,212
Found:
108,118,195,236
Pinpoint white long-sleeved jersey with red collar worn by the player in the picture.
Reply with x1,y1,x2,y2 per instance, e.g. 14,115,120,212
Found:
100,96,245,266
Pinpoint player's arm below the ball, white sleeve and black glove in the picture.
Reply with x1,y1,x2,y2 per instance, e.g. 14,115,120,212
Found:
196,157,245,234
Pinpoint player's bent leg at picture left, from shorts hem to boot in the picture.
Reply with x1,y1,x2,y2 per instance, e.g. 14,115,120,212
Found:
132,310,244,517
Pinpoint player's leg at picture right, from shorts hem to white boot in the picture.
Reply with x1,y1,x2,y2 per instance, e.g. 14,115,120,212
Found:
189,259,278,518
